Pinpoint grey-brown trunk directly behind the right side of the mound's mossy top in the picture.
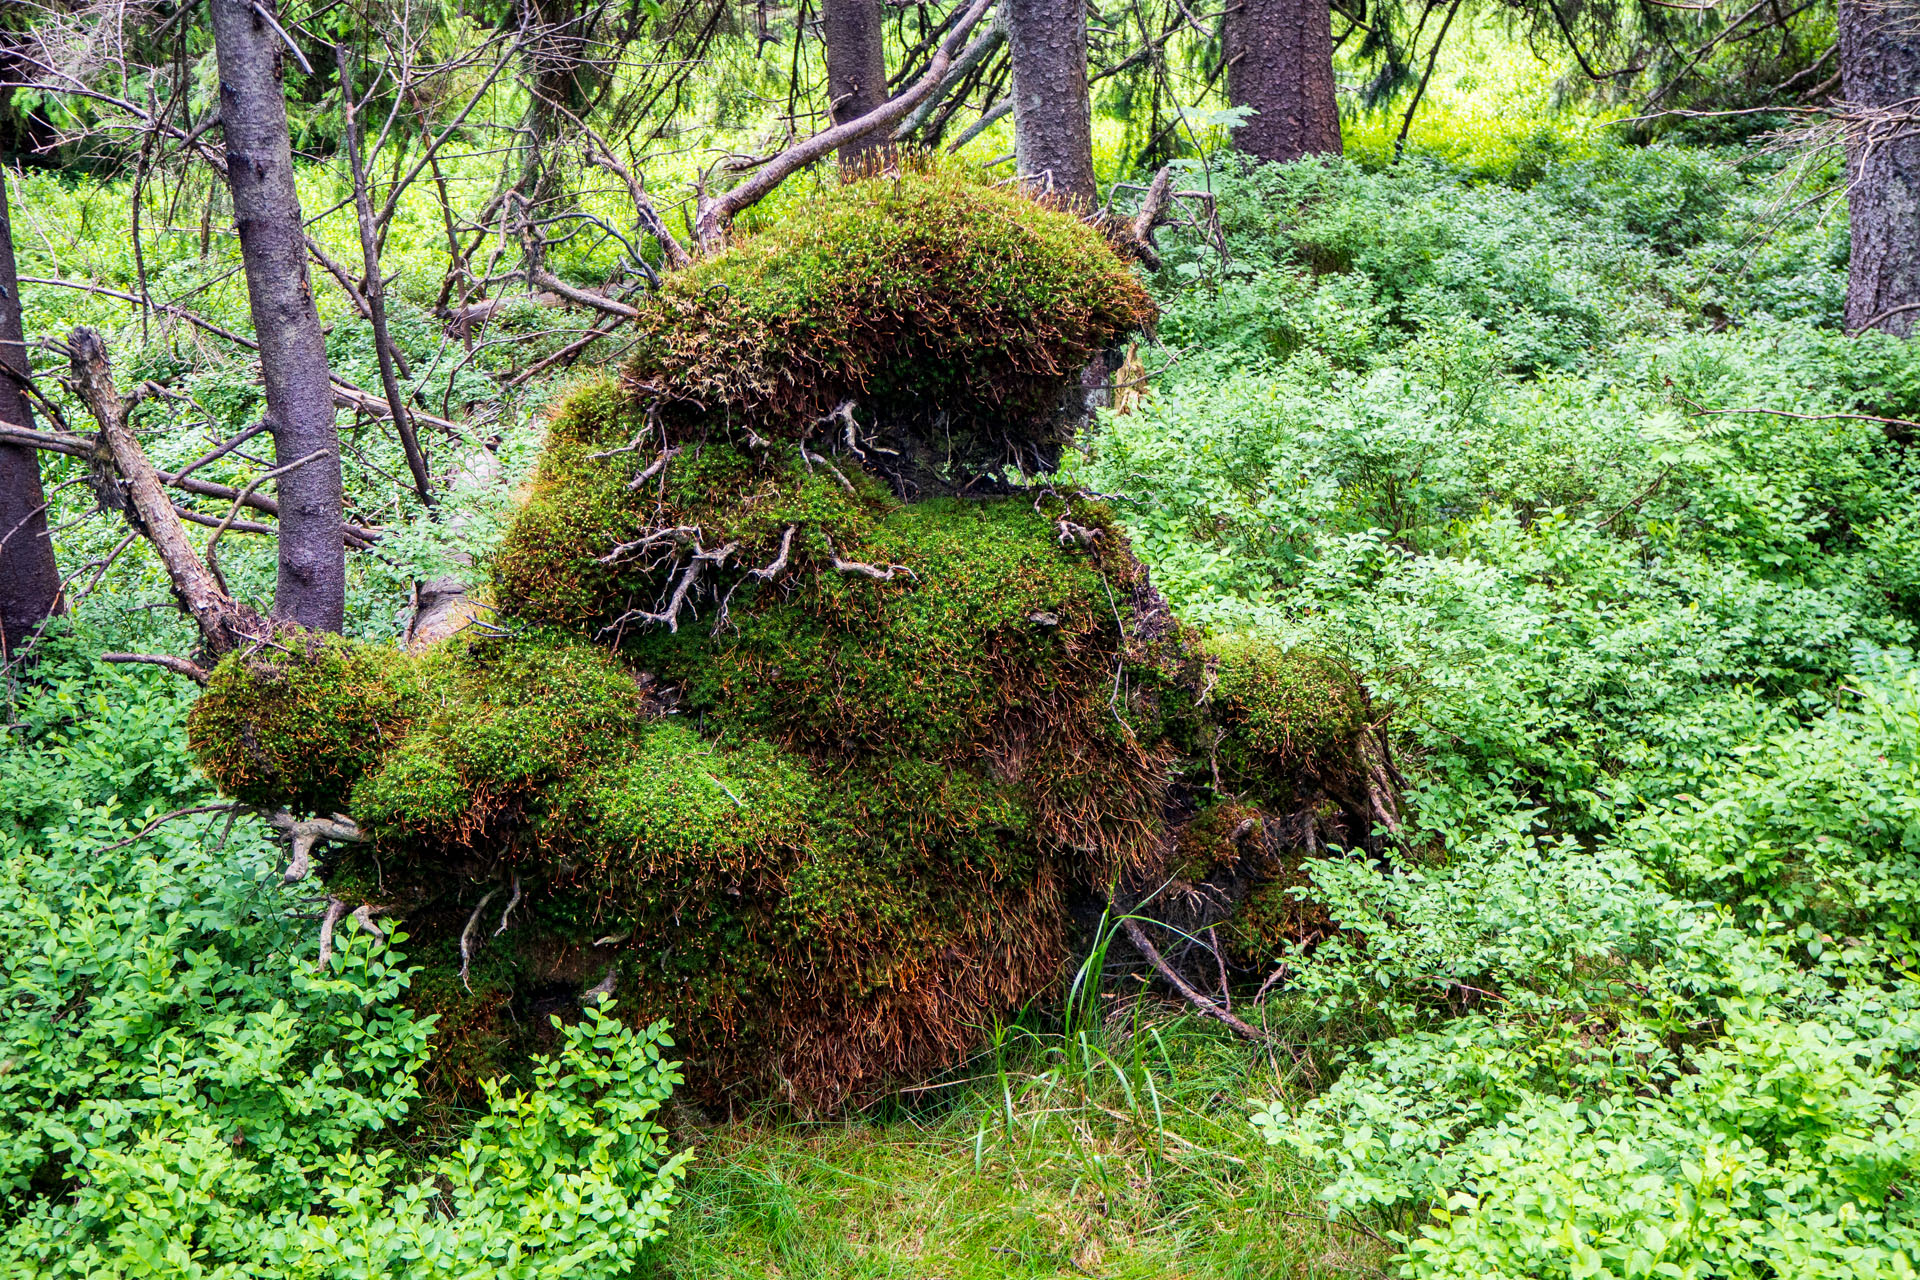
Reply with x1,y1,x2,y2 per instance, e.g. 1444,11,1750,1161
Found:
1006,0,1098,207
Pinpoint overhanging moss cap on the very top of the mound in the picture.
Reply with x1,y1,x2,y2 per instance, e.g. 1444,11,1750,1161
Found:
628,163,1154,470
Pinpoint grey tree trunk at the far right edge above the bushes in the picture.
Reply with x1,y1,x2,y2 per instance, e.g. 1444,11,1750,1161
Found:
1839,0,1920,338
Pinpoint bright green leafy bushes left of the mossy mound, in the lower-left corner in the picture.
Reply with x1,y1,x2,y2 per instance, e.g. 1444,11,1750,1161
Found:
0,649,685,1278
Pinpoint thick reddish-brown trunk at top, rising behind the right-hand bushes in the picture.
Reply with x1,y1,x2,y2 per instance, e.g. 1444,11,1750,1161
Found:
1225,0,1340,161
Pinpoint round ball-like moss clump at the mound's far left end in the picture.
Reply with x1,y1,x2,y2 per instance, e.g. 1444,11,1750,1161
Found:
186,628,419,814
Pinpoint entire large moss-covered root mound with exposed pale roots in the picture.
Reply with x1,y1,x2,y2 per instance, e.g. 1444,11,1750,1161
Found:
194,173,1363,1107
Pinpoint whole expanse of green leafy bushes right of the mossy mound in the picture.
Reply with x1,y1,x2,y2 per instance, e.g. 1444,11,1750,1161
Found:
1105,148,1920,1278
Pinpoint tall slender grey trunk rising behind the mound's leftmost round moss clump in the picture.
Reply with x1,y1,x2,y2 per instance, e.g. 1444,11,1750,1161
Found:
209,0,346,631
